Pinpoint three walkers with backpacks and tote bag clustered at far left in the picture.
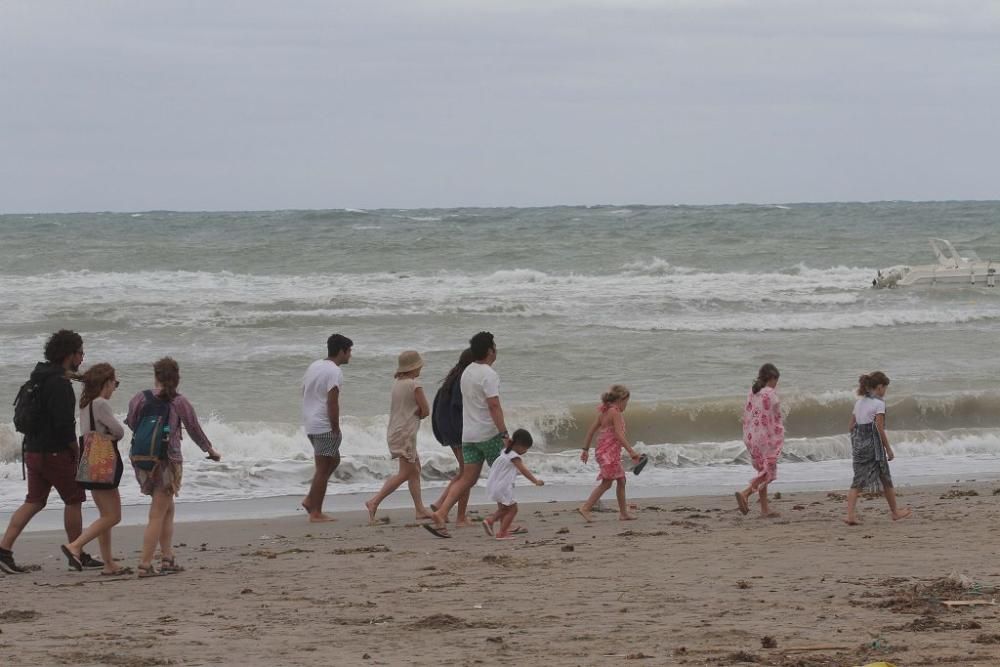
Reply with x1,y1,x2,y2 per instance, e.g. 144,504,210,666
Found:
0,329,221,578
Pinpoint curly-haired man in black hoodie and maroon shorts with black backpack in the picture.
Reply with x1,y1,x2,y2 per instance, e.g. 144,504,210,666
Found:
0,329,104,574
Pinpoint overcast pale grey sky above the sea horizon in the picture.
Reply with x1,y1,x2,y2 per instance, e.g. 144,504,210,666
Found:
0,0,1000,212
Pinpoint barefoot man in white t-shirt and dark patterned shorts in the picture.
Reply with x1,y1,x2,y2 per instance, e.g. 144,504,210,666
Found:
302,334,354,522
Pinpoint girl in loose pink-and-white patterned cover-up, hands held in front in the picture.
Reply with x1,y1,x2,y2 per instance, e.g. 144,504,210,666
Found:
736,364,785,518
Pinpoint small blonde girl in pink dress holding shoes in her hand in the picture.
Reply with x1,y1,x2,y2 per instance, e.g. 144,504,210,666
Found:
578,384,639,522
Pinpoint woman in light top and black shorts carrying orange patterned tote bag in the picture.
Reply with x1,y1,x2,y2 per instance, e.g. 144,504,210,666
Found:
62,364,132,576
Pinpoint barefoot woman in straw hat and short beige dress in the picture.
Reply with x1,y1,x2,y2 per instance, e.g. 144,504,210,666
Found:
365,350,431,524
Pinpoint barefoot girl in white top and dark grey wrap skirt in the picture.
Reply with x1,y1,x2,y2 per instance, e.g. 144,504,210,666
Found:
844,371,912,526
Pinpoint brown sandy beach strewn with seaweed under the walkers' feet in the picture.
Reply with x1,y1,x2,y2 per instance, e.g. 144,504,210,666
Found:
0,483,1000,667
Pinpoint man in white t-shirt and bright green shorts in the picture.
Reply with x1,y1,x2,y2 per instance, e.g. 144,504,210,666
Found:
424,331,510,537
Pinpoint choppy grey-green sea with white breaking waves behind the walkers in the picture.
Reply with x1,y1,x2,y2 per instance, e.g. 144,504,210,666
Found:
0,201,1000,511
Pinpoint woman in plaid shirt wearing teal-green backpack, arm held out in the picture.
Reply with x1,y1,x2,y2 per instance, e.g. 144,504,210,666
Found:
125,357,222,578
